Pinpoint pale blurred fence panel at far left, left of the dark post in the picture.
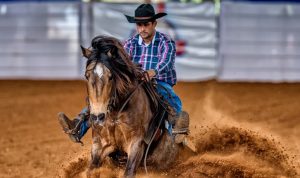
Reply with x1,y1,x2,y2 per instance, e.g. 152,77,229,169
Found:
0,2,79,79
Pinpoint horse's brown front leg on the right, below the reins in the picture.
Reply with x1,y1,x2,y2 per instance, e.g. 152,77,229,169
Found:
124,138,145,178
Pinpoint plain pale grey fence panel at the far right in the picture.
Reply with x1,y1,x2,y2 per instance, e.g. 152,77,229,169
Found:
218,2,300,82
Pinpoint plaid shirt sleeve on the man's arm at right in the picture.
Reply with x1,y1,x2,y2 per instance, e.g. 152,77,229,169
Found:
155,40,176,74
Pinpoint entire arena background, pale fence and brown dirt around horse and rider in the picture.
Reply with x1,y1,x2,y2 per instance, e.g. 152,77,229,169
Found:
0,0,300,178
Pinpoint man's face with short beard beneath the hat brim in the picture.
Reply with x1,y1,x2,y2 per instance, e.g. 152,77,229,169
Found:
136,21,157,40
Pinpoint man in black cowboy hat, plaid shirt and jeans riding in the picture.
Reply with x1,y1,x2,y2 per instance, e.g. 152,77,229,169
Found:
58,4,188,146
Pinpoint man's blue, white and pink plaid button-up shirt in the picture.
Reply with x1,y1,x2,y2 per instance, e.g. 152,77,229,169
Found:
124,31,177,86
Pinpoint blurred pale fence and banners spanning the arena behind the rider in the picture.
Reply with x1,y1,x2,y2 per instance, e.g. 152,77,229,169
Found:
0,0,300,82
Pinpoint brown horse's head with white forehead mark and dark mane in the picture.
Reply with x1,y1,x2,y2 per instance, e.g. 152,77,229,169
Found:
81,36,141,119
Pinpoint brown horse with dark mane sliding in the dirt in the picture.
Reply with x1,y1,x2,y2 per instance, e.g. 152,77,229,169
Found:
81,36,192,177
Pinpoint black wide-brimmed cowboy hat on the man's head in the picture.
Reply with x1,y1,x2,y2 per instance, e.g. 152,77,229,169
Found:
125,4,167,23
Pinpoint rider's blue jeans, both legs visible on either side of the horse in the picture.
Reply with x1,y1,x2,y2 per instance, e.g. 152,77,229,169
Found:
79,80,182,140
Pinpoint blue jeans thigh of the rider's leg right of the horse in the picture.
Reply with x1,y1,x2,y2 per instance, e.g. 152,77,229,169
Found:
156,80,182,115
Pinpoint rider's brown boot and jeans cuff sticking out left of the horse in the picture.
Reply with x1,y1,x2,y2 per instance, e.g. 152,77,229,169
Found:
58,110,89,143
